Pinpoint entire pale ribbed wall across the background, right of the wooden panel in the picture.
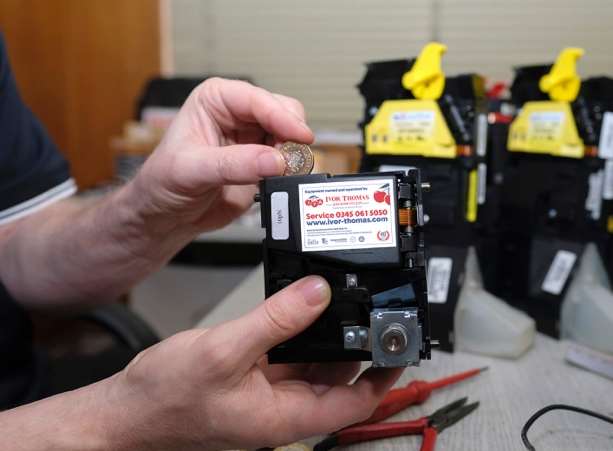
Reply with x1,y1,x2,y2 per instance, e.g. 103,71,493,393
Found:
172,0,613,130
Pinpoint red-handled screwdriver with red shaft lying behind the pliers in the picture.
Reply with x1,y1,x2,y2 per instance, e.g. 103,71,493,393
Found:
356,367,488,426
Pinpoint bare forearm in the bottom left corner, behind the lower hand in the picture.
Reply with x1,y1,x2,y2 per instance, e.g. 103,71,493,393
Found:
0,373,160,451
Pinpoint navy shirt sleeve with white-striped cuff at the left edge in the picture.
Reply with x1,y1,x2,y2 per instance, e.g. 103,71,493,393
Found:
0,34,76,224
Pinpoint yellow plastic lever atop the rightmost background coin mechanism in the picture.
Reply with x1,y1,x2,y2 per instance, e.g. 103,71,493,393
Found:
539,47,584,102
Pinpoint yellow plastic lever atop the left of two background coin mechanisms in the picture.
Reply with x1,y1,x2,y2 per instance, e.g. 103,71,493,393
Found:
402,42,447,100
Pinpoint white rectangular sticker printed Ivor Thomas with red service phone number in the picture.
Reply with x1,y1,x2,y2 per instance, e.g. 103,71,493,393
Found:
298,178,396,252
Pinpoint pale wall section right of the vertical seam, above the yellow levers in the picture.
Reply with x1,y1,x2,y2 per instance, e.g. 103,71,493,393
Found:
437,0,613,81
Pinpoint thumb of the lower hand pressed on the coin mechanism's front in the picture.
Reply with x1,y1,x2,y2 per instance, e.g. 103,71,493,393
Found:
235,276,331,365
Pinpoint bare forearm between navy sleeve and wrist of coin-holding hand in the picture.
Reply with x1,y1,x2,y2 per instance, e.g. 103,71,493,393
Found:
0,184,196,307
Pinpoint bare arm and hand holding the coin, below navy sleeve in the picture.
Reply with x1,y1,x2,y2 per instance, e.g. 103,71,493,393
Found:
0,79,313,307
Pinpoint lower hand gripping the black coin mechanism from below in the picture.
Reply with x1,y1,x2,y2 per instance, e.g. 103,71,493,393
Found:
108,276,401,451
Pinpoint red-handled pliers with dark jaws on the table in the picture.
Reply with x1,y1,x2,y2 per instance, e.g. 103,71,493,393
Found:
313,398,479,451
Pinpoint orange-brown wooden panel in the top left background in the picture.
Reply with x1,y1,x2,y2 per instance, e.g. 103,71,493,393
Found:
0,0,160,188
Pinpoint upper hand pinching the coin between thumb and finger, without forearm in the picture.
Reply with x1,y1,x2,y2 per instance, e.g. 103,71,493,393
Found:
128,78,313,234
